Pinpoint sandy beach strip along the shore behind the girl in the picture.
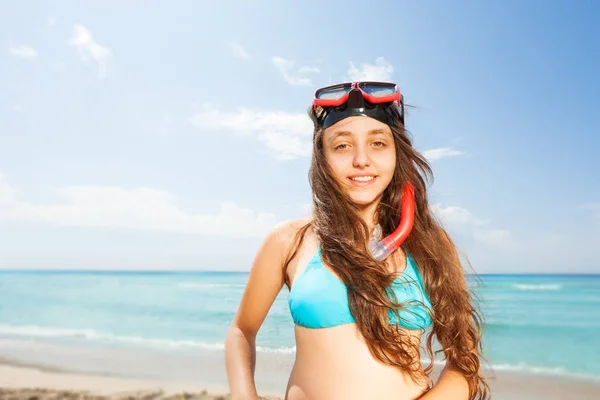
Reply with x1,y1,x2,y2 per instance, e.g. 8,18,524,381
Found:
0,360,600,400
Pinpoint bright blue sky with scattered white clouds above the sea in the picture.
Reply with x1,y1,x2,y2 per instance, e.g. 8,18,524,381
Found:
0,0,600,273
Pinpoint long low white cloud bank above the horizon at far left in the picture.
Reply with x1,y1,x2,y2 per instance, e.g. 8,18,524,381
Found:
0,174,276,237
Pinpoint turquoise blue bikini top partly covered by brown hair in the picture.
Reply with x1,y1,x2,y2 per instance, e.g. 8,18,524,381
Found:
288,246,431,330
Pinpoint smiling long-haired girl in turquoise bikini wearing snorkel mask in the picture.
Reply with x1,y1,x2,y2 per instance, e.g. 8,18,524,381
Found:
225,82,489,400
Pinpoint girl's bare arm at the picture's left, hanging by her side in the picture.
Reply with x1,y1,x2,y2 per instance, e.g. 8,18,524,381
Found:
225,222,287,400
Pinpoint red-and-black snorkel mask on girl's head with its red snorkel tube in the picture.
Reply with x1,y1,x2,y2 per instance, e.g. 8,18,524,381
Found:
313,82,415,261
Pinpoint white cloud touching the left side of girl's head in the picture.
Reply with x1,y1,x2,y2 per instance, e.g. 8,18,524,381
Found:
190,105,313,160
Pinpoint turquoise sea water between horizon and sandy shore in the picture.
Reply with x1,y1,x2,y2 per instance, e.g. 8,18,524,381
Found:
0,271,600,380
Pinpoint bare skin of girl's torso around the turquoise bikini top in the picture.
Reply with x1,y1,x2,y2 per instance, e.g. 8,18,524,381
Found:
286,222,428,400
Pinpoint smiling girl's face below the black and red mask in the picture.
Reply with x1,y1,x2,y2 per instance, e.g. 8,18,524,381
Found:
322,116,396,208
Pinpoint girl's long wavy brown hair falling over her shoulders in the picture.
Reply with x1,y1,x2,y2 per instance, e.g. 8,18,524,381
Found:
284,107,489,400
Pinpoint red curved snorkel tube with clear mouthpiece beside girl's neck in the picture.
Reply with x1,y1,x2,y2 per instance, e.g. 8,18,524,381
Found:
369,183,415,261
